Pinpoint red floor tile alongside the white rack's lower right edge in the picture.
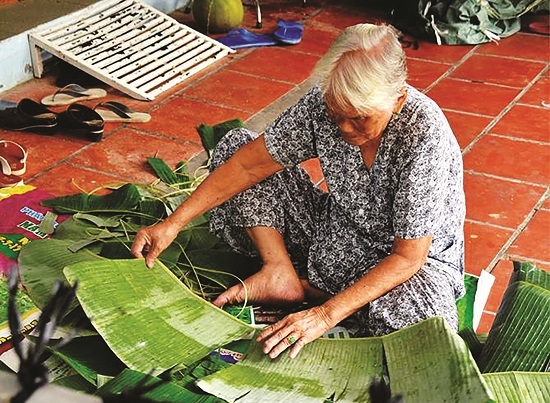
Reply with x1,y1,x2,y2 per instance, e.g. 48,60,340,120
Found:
184,70,293,113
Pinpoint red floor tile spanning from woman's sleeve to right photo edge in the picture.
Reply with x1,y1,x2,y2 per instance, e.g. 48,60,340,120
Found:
464,134,550,186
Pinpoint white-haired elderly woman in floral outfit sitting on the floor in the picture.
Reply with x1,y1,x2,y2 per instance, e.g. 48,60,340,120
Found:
132,24,465,358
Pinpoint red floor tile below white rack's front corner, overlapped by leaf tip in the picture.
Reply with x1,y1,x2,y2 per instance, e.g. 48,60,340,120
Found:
139,97,251,143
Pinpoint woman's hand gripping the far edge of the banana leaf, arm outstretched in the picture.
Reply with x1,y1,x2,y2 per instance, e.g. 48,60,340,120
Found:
132,219,179,268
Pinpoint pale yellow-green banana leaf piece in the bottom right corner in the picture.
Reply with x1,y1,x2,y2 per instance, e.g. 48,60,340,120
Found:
483,372,550,403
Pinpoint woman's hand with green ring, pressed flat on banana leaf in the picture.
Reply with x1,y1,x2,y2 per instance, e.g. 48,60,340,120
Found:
256,305,335,358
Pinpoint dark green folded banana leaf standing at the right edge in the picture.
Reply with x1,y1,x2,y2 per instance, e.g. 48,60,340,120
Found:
479,281,550,373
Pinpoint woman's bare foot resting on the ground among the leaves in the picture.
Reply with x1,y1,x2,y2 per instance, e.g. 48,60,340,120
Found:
213,262,305,307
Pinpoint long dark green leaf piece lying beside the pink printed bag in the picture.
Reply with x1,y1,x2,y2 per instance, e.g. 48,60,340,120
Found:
40,183,141,214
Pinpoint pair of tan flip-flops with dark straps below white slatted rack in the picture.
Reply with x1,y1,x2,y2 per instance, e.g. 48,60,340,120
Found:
40,84,151,123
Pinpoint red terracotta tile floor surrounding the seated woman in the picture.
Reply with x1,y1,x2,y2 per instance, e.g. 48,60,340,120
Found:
0,0,550,333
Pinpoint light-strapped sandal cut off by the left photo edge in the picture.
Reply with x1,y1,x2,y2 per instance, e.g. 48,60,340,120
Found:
0,140,28,188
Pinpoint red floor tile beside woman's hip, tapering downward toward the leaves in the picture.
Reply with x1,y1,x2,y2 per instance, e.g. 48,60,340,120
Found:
464,220,513,276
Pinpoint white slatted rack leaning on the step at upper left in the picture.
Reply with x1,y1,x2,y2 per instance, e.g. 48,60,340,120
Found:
29,0,235,100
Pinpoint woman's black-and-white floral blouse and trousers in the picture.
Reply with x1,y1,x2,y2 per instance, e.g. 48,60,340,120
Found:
211,87,465,335
